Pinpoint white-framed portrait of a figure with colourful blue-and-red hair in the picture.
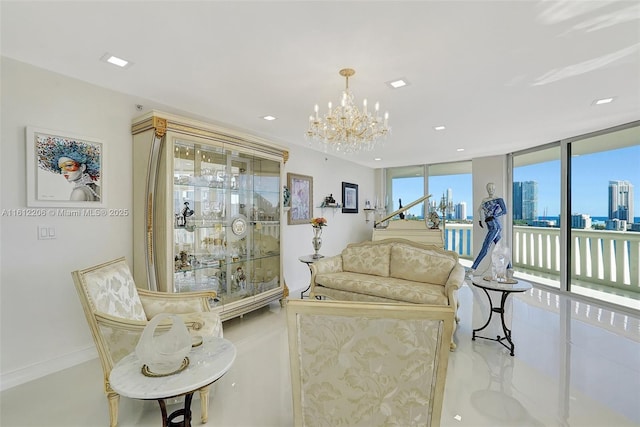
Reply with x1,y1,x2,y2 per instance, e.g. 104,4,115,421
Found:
26,127,105,208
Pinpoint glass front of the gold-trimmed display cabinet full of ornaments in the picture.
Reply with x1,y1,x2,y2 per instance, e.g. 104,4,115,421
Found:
173,140,281,304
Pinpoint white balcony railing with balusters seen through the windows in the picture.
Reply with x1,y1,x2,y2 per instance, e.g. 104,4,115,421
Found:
445,223,640,293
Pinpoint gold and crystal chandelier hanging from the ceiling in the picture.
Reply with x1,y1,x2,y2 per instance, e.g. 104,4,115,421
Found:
306,68,391,153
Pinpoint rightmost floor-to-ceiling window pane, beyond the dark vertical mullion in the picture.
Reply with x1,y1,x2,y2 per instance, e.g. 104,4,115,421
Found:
567,126,640,308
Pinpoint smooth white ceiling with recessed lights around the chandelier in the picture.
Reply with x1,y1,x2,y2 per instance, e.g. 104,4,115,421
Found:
0,0,640,167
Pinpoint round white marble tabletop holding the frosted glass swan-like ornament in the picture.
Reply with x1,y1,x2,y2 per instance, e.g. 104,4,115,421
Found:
109,337,236,399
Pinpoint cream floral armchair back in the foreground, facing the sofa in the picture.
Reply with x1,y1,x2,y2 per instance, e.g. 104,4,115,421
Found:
287,300,454,427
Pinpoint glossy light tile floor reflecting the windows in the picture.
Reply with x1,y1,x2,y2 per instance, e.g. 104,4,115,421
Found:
0,285,640,427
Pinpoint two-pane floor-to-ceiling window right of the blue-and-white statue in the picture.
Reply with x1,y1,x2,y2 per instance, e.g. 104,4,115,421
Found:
511,123,640,309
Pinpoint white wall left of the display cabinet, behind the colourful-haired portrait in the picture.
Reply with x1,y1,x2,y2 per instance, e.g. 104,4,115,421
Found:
0,58,135,389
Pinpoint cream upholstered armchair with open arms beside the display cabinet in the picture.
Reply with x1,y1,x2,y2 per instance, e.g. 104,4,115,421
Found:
71,258,222,427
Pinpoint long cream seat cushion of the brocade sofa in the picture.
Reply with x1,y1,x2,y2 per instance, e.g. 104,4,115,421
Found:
315,272,449,305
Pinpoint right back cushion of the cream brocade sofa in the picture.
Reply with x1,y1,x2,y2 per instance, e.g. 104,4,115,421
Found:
390,244,457,285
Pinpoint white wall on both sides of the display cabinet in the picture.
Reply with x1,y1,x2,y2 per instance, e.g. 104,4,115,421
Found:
0,58,373,389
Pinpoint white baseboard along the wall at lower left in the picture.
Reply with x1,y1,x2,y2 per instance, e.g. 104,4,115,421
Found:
0,346,98,391
